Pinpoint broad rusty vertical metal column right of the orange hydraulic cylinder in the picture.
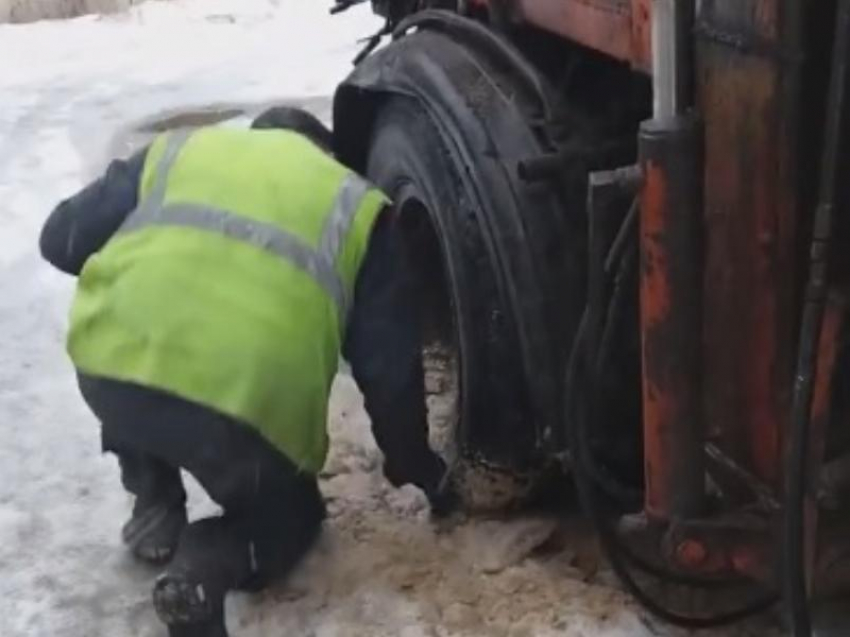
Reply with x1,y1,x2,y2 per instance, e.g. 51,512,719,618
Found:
697,0,799,486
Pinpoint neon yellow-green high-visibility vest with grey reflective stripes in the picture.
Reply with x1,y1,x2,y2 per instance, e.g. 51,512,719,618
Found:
68,128,387,472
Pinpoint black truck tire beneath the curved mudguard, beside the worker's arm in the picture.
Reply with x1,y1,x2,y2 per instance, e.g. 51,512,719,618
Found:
366,96,533,509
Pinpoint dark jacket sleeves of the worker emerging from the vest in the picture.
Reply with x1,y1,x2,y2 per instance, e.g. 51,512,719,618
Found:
40,150,443,492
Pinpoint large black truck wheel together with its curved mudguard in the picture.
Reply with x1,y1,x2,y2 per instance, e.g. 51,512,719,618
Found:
333,22,608,501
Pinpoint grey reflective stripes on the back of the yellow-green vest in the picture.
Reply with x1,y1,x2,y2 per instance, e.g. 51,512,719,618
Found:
119,130,371,318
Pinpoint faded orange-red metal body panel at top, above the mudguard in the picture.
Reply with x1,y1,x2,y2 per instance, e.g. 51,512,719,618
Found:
515,0,651,71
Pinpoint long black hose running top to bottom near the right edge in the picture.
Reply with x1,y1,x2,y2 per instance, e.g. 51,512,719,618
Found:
783,0,850,637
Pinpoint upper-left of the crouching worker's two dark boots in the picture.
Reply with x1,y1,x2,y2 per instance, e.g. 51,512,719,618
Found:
121,497,187,564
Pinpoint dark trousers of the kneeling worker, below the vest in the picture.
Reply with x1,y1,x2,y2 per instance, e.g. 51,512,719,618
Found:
79,374,325,595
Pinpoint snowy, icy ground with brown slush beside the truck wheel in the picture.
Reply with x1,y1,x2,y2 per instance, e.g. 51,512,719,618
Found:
0,0,780,637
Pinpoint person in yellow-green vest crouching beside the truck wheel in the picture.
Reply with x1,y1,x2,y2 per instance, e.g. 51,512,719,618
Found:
41,108,454,637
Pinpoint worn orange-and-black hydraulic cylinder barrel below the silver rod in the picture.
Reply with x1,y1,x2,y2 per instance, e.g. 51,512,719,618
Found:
639,117,705,521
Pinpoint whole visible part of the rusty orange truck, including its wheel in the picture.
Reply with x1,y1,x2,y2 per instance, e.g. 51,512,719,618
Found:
334,0,850,637
